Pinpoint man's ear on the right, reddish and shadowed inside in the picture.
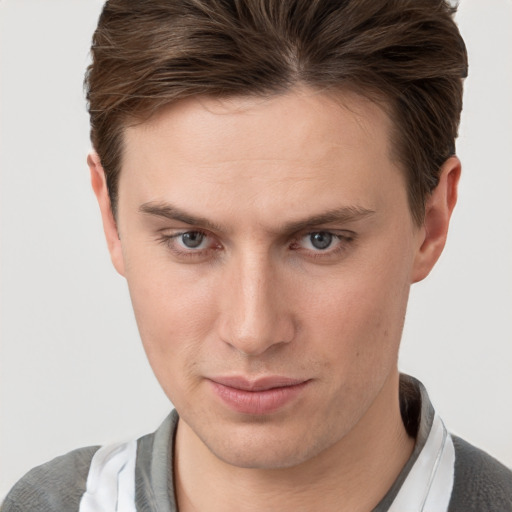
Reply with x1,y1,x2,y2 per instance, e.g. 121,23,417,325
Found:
411,156,461,283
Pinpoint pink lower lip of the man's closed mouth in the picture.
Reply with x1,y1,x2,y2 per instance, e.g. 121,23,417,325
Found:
210,381,309,414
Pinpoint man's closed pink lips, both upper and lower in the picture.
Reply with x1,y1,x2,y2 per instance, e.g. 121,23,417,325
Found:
209,376,310,415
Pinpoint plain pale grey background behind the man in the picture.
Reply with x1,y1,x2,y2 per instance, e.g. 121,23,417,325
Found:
0,0,512,498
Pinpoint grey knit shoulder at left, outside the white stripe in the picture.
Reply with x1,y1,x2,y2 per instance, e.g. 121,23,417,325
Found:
2,446,99,512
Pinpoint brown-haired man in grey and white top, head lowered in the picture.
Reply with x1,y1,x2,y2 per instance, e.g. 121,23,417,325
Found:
4,0,512,511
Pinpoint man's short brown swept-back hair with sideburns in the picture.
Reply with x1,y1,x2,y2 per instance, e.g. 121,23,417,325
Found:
85,0,467,223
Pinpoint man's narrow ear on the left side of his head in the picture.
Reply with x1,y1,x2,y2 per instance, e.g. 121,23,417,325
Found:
87,151,124,276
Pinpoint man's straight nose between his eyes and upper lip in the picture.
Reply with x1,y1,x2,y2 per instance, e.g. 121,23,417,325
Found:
220,255,296,356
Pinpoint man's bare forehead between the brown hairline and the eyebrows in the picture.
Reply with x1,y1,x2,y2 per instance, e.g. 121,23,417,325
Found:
119,89,404,226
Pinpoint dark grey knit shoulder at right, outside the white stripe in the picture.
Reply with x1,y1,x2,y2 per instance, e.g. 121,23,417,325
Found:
448,436,512,512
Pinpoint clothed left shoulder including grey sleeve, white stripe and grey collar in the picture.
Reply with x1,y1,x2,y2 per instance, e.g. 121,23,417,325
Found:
1,410,178,512
